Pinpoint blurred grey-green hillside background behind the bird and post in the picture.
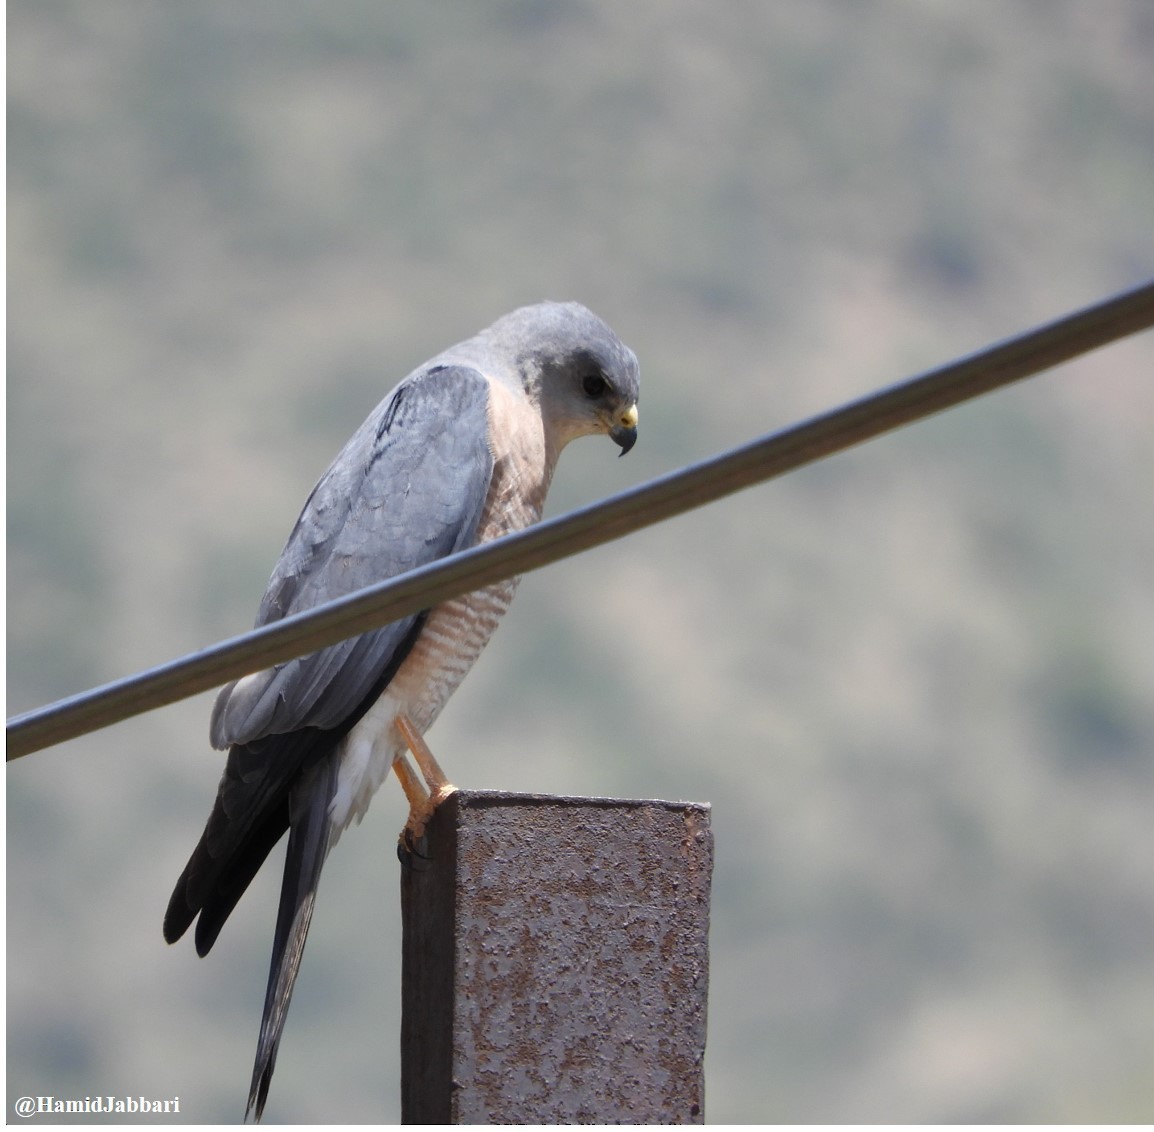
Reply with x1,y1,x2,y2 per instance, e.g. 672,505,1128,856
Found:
7,0,1154,1123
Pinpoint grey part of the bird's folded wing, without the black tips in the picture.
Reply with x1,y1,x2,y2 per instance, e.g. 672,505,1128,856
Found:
211,366,493,749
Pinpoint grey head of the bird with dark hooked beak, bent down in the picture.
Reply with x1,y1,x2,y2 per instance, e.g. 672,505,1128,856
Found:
490,302,640,456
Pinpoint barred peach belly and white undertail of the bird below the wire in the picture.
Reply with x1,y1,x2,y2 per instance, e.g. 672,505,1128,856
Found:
329,578,519,830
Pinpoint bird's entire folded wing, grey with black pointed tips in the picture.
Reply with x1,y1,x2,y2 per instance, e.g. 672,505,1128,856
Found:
164,366,493,955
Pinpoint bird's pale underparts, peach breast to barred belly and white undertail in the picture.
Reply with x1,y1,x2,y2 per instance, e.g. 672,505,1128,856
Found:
329,382,553,830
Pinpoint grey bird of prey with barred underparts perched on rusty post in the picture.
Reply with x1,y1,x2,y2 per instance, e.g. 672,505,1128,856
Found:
164,302,638,1120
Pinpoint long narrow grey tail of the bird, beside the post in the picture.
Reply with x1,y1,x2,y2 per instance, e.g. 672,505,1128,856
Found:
245,752,339,1120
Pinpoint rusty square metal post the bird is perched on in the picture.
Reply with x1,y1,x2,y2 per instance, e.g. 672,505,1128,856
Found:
400,792,713,1124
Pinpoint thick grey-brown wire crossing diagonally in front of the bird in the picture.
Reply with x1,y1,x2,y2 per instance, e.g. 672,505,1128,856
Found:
8,280,1154,762
